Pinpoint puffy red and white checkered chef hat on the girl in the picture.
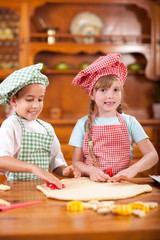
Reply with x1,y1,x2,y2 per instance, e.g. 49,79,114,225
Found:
72,53,127,96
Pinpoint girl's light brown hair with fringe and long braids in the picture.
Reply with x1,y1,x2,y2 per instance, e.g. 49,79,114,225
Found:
87,75,124,167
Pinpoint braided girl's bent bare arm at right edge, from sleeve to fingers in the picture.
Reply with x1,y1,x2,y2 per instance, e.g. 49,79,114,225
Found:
109,139,159,182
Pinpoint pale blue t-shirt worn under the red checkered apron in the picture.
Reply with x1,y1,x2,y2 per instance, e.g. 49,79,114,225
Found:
69,113,148,159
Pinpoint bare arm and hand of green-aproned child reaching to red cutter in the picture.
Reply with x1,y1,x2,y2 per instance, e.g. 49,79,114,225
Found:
0,156,62,188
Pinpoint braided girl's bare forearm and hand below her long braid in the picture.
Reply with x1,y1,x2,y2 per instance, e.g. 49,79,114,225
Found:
72,147,108,182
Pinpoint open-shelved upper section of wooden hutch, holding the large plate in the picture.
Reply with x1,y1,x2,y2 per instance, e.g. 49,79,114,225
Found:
28,0,160,118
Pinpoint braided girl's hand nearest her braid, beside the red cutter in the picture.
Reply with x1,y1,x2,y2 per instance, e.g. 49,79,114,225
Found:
89,167,109,182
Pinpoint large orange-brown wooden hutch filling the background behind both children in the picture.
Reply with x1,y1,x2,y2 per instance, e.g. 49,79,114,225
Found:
0,0,160,176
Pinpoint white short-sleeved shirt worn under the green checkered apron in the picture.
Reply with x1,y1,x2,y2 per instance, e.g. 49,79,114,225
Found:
0,115,67,174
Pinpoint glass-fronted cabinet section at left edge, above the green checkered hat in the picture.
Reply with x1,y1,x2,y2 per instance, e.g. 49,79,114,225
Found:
0,7,20,77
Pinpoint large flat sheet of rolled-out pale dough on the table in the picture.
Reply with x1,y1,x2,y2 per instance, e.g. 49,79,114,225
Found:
37,177,152,201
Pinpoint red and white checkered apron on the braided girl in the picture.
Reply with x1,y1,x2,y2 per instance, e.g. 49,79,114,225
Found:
83,113,131,175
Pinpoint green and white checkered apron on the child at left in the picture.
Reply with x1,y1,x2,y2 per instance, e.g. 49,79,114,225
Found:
7,114,53,180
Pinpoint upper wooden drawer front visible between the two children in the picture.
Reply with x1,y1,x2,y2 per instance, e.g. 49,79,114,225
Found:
54,127,73,143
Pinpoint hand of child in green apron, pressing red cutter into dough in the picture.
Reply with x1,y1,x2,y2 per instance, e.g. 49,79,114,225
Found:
32,165,62,188
